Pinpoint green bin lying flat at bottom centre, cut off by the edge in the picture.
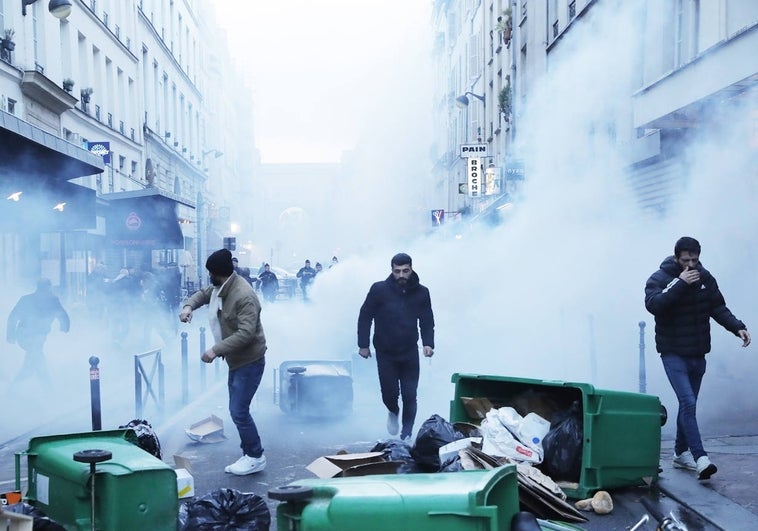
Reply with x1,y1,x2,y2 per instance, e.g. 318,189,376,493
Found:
269,465,519,531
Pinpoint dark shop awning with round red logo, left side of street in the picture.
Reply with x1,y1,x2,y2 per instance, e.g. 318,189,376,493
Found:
102,188,194,249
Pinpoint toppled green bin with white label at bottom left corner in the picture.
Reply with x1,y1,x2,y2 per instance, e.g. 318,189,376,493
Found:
16,430,179,531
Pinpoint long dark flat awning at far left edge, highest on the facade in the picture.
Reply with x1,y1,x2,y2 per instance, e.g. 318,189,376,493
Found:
0,111,104,181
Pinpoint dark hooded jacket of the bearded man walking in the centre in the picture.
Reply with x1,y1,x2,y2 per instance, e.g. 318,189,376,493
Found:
358,271,434,352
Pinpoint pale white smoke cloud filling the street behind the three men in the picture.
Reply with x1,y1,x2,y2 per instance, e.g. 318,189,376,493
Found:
0,2,758,454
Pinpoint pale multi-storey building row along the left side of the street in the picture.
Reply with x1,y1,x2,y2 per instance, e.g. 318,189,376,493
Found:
0,0,255,295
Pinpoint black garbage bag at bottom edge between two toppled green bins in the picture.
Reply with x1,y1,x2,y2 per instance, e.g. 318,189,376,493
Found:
177,488,271,531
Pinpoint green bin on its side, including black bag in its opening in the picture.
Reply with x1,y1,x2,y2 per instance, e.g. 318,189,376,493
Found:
450,373,665,498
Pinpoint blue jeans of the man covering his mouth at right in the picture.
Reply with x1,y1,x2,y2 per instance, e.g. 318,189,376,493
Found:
661,354,707,460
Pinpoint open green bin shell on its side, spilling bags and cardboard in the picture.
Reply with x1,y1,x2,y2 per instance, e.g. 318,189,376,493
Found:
450,373,664,498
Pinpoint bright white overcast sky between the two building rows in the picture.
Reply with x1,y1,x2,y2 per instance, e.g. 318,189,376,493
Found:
216,0,431,163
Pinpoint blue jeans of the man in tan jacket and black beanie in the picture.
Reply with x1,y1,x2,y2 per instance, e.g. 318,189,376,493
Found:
228,358,266,457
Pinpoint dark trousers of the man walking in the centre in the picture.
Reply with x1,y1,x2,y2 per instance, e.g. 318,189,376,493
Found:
376,346,419,438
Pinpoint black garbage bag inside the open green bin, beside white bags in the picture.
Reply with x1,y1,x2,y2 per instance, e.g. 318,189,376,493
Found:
539,400,584,482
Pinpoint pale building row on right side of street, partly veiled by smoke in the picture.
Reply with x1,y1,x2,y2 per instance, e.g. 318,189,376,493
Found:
433,0,758,223
